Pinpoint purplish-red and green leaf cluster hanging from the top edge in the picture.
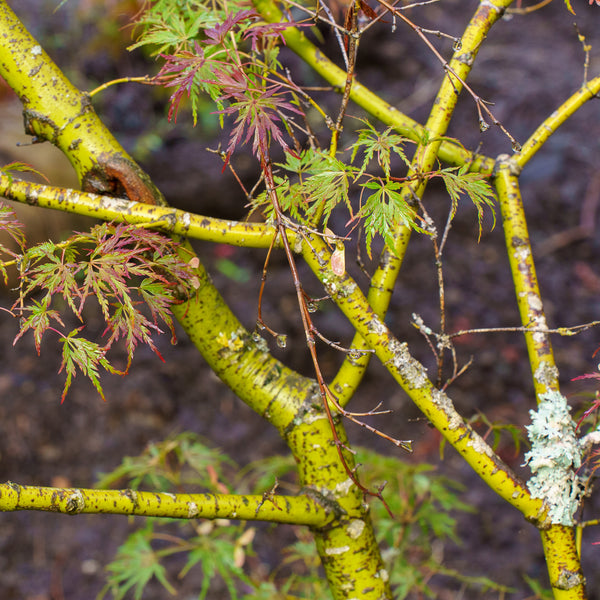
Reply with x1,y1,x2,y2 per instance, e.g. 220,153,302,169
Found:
131,1,302,162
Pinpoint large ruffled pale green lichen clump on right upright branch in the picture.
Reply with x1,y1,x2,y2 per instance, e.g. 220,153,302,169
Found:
525,392,581,526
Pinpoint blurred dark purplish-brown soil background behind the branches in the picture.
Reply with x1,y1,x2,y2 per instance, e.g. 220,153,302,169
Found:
0,0,600,600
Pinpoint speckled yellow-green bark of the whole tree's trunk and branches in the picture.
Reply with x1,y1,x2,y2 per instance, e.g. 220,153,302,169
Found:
0,0,600,600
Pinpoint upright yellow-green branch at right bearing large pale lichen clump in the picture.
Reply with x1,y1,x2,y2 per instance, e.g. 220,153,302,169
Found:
496,161,586,600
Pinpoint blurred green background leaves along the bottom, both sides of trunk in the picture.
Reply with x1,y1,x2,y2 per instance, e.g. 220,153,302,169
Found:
98,433,506,600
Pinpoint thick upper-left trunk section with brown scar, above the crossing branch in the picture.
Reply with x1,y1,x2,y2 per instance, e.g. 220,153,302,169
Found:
0,0,163,204
